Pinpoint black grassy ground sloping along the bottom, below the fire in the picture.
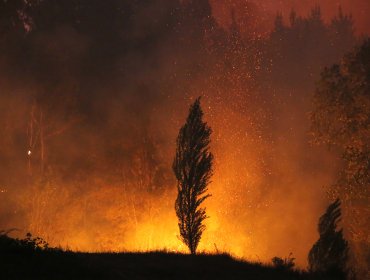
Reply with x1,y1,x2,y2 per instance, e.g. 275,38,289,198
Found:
0,234,339,280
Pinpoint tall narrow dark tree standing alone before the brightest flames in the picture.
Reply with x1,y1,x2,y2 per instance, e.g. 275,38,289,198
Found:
173,98,213,254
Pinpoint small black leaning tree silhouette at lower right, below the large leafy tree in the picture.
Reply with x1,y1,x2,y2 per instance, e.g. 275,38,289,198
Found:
308,199,348,275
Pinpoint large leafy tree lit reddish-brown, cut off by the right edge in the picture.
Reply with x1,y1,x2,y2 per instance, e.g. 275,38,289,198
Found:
311,39,370,278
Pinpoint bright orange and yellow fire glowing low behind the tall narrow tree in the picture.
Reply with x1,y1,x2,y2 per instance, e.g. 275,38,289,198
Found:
7,96,324,267
